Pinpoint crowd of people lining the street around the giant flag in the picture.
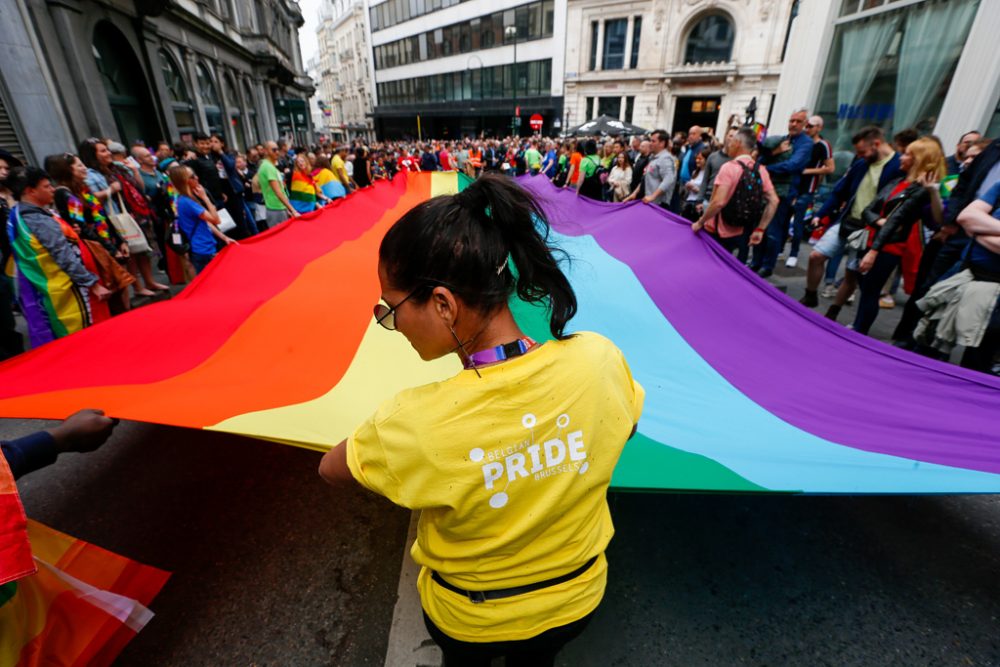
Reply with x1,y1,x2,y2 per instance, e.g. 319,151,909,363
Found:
0,109,1000,371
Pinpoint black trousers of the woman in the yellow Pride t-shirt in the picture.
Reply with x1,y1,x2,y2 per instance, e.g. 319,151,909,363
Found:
424,612,594,667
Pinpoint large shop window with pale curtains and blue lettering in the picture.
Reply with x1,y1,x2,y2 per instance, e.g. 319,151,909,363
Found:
816,0,979,151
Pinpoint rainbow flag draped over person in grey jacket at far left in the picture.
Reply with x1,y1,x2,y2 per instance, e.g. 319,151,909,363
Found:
7,205,96,347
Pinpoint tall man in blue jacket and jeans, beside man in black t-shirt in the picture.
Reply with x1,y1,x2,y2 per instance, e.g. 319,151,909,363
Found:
751,108,813,278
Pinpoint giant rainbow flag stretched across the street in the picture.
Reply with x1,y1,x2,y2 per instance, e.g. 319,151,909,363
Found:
0,173,1000,493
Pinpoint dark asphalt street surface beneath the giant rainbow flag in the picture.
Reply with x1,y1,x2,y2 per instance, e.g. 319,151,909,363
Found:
7,252,1000,667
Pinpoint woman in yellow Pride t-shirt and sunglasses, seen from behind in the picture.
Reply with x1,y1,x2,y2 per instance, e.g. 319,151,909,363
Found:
320,174,643,665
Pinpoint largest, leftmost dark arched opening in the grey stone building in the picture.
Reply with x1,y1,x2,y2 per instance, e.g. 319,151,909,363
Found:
92,21,162,146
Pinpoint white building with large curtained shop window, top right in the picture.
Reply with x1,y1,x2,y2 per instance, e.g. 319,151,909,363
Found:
775,0,1000,153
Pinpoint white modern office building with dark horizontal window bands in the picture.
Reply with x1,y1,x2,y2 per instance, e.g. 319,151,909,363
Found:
368,0,567,138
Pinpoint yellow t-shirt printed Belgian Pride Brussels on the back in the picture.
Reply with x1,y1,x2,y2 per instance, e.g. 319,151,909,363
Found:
347,333,644,642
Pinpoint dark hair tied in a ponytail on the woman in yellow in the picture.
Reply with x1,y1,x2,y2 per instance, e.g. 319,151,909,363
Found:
379,174,576,339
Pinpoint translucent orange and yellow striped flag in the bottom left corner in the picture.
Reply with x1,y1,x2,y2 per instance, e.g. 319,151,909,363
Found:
0,521,170,667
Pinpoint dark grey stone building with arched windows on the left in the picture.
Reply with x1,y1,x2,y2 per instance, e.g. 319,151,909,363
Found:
0,0,313,161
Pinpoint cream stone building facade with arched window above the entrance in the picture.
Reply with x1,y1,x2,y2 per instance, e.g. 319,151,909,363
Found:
563,0,798,132
